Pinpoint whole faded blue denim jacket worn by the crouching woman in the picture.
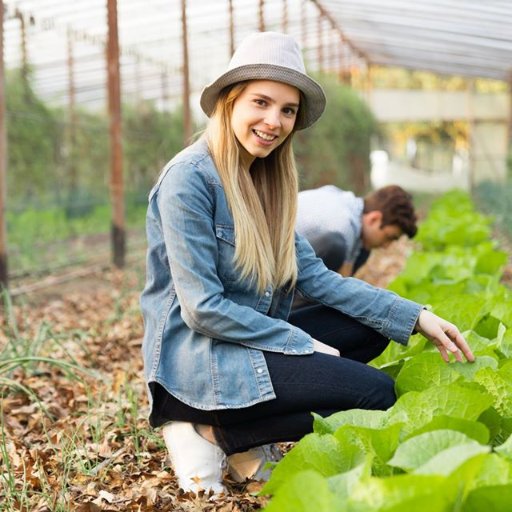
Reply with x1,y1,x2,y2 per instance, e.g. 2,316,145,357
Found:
141,140,421,410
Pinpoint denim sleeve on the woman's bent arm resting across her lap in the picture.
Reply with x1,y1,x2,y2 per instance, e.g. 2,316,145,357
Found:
157,163,313,355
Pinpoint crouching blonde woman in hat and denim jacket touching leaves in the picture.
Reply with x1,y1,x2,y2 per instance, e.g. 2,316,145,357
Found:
141,32,473,492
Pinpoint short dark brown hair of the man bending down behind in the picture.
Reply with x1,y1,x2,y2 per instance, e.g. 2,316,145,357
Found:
363,185,418,238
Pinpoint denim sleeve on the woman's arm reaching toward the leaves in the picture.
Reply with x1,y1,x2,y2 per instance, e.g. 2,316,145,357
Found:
296,235,422,344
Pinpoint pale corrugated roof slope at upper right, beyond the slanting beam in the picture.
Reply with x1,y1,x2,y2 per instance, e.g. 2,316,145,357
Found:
319,0,512,81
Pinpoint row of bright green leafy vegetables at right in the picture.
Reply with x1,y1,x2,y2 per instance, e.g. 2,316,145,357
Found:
262,191,512,512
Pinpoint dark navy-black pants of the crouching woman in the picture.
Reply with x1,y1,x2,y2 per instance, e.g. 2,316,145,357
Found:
151,305,396,455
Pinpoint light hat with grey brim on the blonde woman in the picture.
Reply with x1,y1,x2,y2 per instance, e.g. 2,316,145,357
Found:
201,32,325,130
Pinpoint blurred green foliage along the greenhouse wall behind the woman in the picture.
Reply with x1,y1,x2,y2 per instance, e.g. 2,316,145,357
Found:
6,70,377,271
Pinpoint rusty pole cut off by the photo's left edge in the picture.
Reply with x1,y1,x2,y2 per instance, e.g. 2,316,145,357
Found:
0,0,8,289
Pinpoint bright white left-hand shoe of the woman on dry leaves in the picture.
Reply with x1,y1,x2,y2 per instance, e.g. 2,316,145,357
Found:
162,421,226,494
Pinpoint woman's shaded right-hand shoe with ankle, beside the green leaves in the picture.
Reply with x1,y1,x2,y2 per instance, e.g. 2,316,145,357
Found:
228,444,283,482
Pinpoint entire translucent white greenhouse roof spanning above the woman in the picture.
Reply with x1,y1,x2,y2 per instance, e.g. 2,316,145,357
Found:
4,0,512,109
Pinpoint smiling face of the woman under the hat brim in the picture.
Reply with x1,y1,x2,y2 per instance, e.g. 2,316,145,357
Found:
231,80,300,164
